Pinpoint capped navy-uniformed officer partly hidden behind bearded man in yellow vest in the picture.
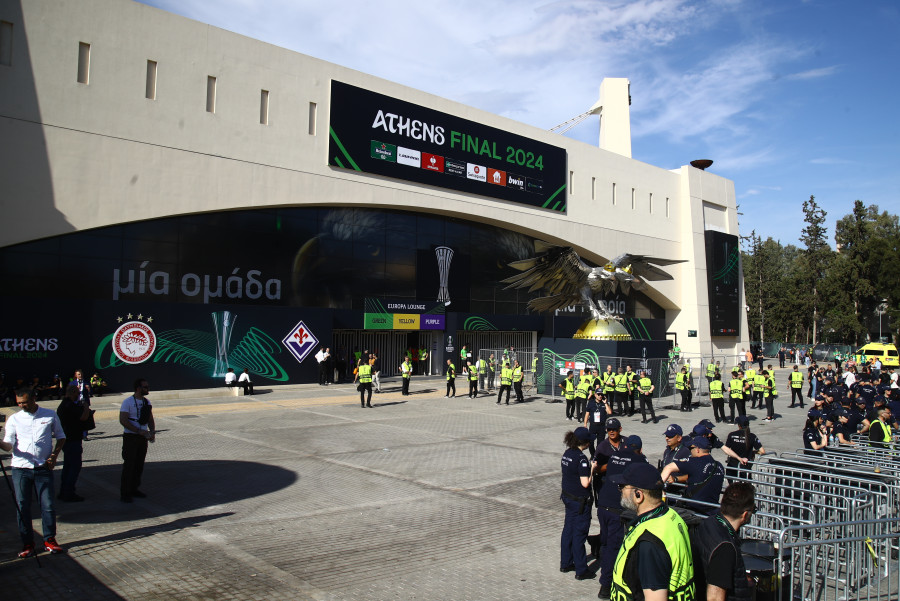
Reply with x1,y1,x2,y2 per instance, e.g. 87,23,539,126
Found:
597,435,647,594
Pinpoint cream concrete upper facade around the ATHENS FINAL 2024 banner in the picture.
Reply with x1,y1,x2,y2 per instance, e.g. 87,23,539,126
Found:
0,0,748,354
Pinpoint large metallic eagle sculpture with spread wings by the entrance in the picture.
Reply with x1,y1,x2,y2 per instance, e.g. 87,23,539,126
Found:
501,240,685,320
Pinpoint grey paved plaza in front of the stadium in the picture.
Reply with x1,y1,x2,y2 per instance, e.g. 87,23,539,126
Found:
0,370,806,601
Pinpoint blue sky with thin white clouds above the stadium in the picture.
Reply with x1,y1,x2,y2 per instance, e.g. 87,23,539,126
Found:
137,0,900,244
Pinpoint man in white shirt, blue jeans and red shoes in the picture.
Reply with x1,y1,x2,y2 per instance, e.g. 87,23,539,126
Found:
0,388,66,557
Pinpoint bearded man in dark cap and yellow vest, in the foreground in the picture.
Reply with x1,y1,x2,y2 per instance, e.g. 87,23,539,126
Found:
598,463,696,601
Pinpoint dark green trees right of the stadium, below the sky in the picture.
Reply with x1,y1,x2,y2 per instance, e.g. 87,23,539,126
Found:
743,196,900,345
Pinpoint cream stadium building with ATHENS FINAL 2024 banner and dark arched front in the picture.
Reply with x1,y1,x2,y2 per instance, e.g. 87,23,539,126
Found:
0,0,748,390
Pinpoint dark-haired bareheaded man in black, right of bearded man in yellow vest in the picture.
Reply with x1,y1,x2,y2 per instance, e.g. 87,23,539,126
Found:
691,482,756,601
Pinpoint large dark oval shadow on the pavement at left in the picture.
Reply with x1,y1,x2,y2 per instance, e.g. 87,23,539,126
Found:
56,458,297,524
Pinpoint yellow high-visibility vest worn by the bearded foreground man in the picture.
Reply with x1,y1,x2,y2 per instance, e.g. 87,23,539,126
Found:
610,505,696,601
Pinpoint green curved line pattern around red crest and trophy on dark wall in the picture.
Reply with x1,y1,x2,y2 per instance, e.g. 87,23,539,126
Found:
94,328,288,382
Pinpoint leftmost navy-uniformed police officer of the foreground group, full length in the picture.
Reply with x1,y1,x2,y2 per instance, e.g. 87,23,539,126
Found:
559,428,597,580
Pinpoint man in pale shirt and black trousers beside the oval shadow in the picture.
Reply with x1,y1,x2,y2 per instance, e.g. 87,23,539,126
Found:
119,378,156,503
